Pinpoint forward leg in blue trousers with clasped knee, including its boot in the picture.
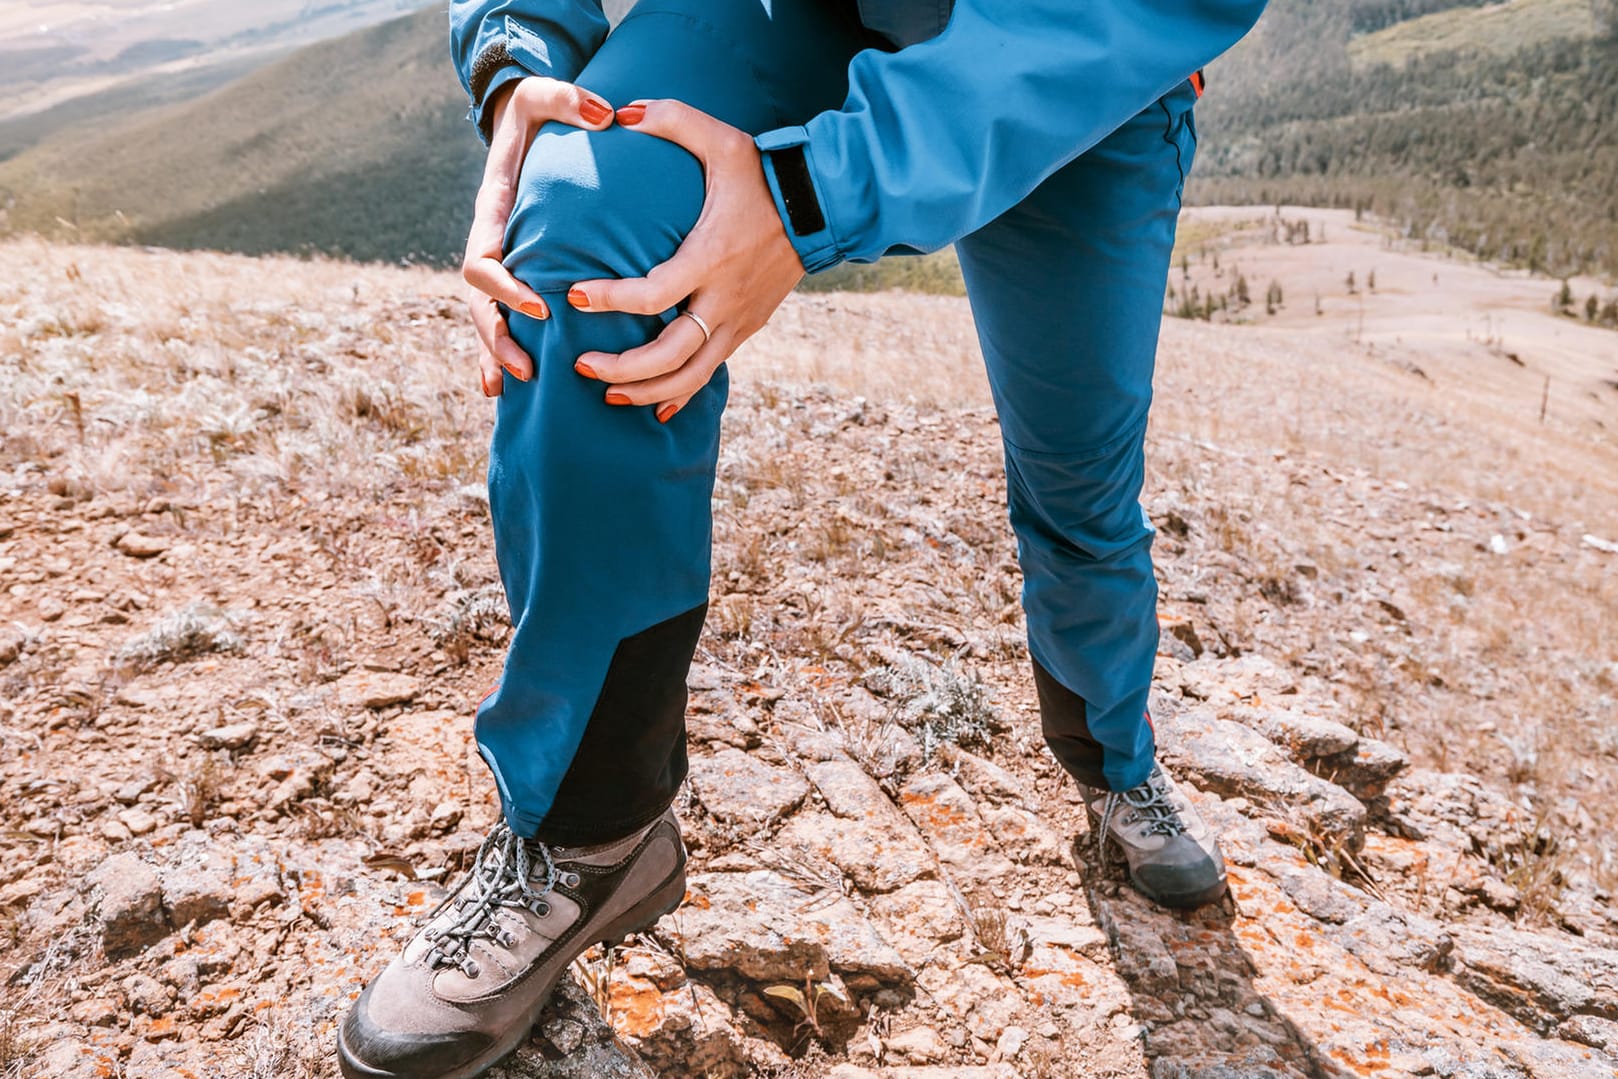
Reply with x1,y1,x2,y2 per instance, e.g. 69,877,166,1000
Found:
338,0,880,1079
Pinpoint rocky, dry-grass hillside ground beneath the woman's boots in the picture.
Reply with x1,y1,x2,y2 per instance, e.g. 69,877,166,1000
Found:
0,237,1618,1079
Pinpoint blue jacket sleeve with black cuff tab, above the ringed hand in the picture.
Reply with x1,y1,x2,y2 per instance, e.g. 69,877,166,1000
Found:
757,0,1265,272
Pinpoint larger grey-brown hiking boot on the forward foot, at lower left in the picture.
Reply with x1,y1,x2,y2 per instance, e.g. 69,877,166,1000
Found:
337,810,686,1079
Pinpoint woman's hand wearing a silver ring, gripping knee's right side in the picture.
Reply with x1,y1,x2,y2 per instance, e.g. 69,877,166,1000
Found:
568,100,804,422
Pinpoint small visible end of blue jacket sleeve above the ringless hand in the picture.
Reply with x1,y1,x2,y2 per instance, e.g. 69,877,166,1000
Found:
450,0,607,142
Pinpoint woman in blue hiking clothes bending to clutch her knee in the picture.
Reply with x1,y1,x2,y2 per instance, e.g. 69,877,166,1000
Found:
340,0,1264,1079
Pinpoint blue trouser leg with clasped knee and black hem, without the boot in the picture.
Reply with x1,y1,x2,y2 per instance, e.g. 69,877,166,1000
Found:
477,0,866,844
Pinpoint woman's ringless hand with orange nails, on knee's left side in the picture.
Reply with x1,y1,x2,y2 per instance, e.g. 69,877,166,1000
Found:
461,76,613,396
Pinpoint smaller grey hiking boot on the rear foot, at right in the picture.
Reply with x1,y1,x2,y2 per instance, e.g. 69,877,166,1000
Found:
1079,764,1225,909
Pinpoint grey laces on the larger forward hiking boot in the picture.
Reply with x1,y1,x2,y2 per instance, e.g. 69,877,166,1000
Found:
427,820,558,977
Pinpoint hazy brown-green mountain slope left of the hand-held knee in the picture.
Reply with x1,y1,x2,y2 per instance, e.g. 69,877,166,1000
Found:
0,10,481,262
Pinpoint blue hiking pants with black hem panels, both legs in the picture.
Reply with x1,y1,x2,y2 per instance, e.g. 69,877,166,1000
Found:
476,0,1196,844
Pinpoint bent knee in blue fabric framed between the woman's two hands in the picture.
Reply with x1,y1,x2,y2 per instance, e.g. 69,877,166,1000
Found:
505,125,702,293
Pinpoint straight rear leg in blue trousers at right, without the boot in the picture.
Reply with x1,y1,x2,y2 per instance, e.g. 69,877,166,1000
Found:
959,84,1196,791
